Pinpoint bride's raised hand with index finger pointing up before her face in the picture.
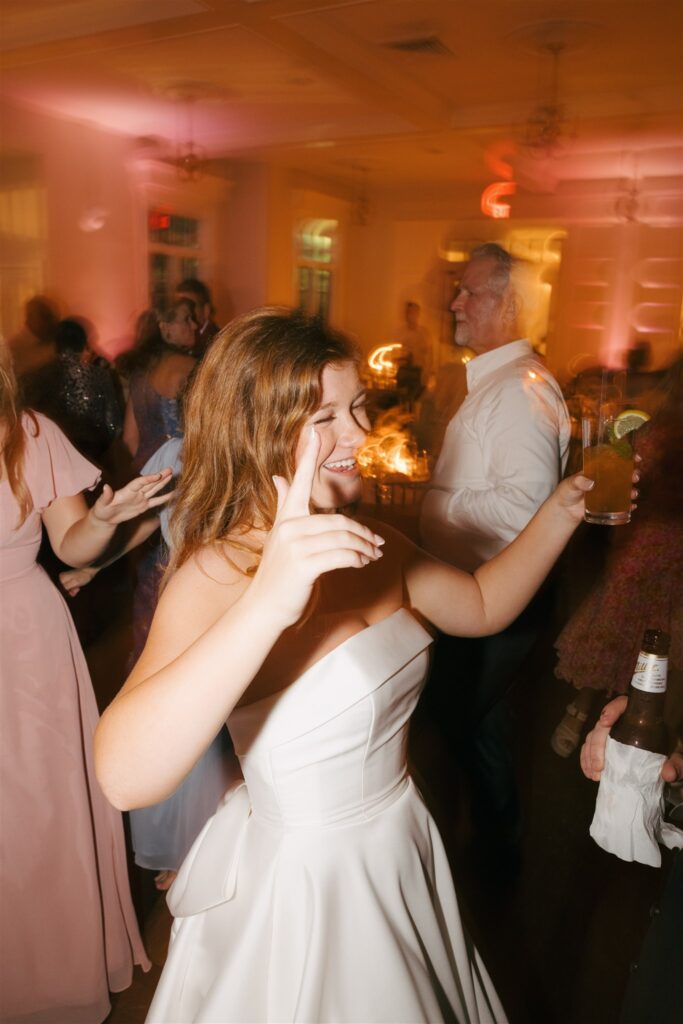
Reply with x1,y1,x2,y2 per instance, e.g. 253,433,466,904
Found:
250,428,384,629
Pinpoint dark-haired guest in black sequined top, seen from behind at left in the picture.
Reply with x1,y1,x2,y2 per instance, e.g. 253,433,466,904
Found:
22,317,123,463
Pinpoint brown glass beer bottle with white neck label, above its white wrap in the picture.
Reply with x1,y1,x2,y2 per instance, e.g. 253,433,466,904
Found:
610,630,670,754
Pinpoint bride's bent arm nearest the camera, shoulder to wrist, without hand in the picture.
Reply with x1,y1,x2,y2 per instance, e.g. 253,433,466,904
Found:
95,552,282,810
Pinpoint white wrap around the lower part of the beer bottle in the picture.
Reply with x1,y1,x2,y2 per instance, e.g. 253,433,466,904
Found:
590,736,683,867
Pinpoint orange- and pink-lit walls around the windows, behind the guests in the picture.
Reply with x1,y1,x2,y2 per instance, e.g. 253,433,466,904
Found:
0,93,683,372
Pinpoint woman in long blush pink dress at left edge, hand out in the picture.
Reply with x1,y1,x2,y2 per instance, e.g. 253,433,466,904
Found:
0,345,170,1024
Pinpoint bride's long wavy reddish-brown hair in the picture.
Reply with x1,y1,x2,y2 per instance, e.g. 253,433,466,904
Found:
169,306,358,572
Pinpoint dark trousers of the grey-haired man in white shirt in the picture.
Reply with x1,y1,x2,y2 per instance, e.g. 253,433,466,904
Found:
425,595,547,847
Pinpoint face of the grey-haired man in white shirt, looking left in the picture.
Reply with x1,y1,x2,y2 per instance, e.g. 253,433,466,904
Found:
451,259,514,354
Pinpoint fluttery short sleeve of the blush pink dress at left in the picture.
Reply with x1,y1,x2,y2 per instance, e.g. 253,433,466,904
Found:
24,413,101,512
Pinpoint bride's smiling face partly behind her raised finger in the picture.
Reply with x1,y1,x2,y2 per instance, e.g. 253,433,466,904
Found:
296,362,370,509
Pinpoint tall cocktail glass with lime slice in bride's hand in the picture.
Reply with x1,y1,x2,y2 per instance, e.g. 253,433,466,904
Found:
582,371,635,526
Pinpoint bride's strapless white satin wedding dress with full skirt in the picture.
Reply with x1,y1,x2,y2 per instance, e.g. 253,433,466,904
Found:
147,608,506,1024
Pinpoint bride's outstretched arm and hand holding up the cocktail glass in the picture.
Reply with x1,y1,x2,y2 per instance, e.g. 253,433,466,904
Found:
404,475,591,636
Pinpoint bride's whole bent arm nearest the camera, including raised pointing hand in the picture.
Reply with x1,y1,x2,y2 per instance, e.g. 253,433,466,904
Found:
95,435,381,810
